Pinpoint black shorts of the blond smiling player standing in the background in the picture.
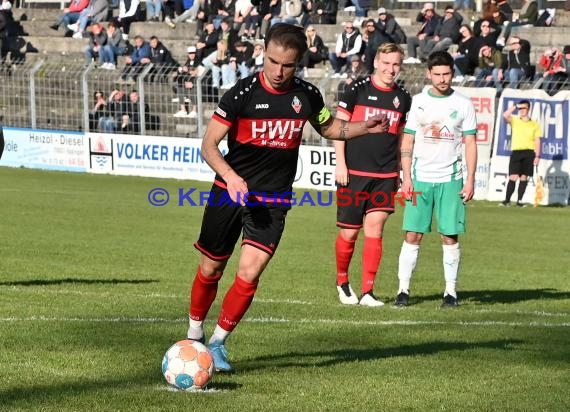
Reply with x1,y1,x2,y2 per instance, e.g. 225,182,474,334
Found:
336,175,399,228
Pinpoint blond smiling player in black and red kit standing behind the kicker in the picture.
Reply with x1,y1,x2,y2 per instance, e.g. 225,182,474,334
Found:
334,43,412,306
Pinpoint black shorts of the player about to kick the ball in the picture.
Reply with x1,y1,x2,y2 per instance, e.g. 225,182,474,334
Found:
194,184,289,261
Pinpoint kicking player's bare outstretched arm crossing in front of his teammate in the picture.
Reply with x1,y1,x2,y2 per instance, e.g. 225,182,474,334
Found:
317,115,390,140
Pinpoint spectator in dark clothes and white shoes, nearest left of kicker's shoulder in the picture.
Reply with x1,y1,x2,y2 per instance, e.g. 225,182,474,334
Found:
172,46,201,119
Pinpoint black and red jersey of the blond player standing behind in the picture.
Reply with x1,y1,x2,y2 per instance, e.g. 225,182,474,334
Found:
337,76,412,177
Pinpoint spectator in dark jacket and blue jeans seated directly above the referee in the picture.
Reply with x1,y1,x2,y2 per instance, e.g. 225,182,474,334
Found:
493,36,530,92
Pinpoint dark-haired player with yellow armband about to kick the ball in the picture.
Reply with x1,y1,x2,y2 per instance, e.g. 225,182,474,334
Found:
188,24,388,371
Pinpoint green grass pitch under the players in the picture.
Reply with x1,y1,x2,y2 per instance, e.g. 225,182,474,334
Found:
0,168,570,411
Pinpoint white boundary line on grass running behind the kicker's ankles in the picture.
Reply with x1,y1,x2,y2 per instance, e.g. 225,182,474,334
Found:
0,316,570,328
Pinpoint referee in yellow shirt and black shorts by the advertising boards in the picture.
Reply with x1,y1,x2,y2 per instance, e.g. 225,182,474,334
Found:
499,100,540,207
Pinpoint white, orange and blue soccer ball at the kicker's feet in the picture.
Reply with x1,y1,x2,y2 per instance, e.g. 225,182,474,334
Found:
162,339,214,391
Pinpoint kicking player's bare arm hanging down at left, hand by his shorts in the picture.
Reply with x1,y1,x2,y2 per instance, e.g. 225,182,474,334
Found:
202,120,248,205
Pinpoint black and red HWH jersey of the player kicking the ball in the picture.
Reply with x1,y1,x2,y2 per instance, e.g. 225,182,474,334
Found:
212,72,330,193
